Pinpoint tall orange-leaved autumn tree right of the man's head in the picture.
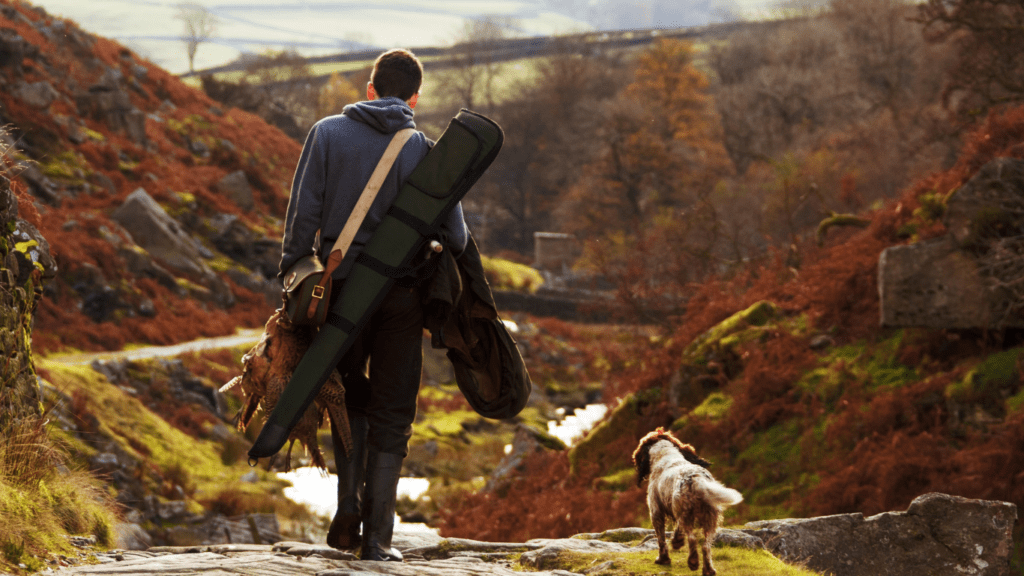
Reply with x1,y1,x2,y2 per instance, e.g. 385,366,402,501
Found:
565,40,728,236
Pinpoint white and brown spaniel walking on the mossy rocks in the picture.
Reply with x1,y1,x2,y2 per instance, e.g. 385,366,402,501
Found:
633,428,743,576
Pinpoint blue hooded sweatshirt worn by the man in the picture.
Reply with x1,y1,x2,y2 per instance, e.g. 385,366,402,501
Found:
278,97,468,280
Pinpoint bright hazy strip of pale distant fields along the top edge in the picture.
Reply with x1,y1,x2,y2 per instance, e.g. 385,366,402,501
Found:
34,0,777,74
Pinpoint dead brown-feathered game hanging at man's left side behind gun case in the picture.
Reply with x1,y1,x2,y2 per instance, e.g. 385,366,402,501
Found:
220,308,352,470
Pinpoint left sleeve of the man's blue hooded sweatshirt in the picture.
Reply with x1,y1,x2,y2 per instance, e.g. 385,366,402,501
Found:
278,125,327,279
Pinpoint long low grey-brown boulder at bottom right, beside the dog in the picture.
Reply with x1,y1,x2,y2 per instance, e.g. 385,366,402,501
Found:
742,493,1017,576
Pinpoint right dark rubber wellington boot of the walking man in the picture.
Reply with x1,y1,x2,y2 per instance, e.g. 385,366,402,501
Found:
359,451,403,562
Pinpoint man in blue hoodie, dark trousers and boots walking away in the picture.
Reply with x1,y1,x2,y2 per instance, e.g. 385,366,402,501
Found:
280,49,468,561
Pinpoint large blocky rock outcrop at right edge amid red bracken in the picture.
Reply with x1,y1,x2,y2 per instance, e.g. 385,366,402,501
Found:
879,158,1024,328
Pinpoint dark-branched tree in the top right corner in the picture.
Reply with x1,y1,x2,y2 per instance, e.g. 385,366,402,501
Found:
916,0,1024,120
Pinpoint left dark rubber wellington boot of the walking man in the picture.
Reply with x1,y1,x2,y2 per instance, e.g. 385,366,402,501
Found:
327,413,367,548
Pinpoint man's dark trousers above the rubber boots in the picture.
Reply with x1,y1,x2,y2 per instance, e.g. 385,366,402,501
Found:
336,286,423,457
